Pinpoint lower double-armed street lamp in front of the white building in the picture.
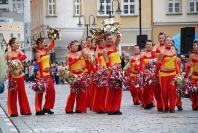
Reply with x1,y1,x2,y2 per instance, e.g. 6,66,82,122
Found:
77,15,96,36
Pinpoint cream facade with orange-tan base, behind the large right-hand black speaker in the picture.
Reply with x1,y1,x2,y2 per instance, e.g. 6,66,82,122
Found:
153,0,198,42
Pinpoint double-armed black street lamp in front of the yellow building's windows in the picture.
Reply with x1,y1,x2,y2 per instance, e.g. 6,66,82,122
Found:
98,0,122,18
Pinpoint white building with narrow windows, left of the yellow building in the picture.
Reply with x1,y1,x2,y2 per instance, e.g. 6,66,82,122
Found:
31,0,86,61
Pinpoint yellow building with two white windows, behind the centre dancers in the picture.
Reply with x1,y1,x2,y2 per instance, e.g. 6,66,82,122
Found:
80,0,152,53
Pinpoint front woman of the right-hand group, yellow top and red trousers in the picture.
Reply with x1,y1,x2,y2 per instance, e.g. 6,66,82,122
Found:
158,37,180,113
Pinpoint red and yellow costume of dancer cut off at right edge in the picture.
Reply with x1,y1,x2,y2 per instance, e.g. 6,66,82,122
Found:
186,57,198,110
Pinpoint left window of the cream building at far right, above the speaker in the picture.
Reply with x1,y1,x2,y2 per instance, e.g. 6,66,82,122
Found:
168,0,181,14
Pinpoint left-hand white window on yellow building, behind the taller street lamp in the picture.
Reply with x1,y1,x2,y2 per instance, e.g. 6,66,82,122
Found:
98,0,112,16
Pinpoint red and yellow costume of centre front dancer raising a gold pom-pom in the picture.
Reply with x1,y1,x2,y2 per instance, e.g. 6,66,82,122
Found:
106,48,122,112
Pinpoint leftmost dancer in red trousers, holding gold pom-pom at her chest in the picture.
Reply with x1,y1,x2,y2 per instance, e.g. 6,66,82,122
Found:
7,38,31,117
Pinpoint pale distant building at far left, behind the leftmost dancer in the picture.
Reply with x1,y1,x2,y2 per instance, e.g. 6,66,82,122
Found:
0,0,24,50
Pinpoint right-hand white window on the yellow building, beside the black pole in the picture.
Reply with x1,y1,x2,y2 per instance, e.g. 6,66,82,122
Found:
122,0,136,15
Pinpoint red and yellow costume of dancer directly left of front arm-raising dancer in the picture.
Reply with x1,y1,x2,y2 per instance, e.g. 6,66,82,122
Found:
93,48,108,112
